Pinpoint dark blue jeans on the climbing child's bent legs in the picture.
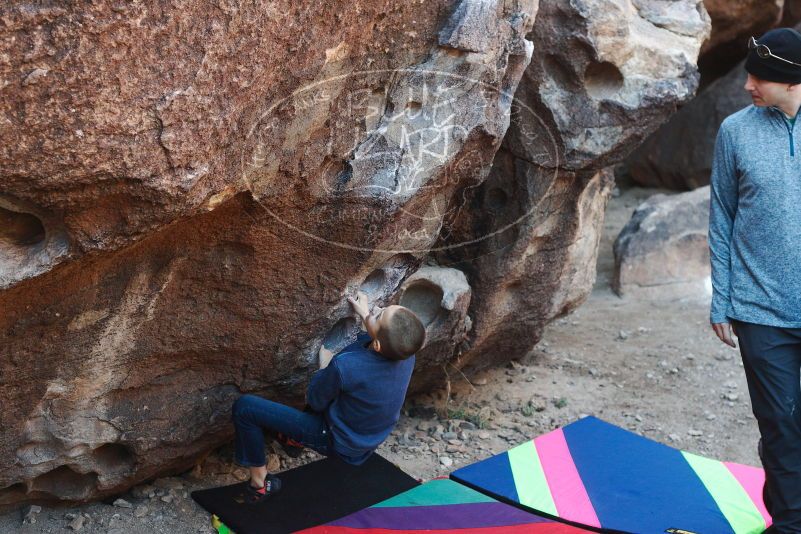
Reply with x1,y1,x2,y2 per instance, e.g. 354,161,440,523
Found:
232,395,333,467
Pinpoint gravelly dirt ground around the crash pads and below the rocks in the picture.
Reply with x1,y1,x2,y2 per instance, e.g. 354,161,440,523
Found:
0,183,758,534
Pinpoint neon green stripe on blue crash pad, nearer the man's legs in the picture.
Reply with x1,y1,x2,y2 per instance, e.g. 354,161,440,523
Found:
681,451,765,534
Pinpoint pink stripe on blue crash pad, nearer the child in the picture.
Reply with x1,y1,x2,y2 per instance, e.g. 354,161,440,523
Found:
534,428,601,528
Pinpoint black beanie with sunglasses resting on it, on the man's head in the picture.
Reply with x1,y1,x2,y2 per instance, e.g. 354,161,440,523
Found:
745,28,801,83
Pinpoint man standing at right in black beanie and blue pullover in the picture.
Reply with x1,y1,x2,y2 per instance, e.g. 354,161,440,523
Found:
709,28,801,534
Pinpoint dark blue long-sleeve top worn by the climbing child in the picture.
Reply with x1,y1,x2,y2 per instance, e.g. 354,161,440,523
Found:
306,333,414,463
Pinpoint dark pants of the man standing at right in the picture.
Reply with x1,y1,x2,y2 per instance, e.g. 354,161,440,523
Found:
732,320,801,534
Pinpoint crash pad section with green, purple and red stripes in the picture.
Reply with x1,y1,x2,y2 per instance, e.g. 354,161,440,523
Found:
301,479,582,534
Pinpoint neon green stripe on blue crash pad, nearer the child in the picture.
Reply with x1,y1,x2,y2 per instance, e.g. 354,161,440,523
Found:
506,441,559,517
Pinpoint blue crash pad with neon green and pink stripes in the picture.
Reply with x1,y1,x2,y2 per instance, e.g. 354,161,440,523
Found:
451,417,771,534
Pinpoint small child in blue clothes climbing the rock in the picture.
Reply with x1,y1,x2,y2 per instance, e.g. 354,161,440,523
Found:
228,291,426,503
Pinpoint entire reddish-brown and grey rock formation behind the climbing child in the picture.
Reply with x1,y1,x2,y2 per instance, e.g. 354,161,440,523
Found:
0,0,798,519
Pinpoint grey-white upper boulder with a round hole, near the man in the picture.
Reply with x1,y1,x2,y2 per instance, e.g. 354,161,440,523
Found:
504,0,710,171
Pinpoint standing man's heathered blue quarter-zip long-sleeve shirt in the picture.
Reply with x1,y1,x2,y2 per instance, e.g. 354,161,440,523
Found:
709,105,801,328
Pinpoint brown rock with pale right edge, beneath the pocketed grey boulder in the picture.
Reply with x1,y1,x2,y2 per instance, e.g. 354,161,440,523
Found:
438,164,613,370
